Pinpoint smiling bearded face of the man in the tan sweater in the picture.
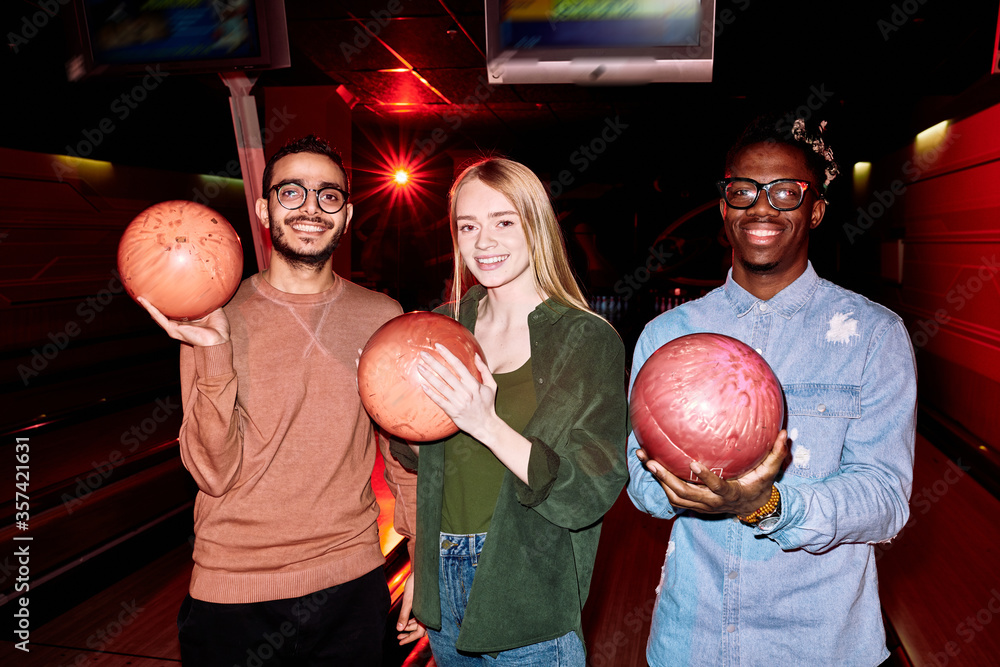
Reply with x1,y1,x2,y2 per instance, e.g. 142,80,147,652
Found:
257,152,354,270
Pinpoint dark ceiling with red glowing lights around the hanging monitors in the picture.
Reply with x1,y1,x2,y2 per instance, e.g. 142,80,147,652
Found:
0,0,998,193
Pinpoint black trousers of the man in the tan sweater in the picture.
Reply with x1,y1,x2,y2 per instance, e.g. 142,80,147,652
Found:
177,568,389,667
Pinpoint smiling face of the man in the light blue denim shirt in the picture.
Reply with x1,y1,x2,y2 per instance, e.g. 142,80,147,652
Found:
719,143,826,299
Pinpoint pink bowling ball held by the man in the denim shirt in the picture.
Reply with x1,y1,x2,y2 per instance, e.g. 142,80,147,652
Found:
629,333,785,482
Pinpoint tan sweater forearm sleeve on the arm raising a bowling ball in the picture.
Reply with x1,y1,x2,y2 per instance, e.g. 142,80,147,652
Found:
179,341,243,497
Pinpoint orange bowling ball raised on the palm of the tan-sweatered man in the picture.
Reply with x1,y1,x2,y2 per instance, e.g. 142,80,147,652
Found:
118,201,243,321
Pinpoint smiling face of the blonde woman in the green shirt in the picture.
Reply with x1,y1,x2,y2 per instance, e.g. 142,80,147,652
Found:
455,179,536,294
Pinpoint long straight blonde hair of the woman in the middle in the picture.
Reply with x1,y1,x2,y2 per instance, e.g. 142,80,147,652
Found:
448,157,593,318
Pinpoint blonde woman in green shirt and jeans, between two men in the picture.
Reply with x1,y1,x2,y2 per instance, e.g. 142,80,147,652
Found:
396,158,628,667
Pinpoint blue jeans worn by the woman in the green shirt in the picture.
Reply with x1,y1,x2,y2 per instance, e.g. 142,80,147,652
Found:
427,533,585,667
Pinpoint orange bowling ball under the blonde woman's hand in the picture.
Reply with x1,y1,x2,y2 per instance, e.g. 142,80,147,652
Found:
358,311,486,442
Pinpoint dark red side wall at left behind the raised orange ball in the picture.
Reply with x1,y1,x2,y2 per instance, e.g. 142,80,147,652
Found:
0,148,256,386
